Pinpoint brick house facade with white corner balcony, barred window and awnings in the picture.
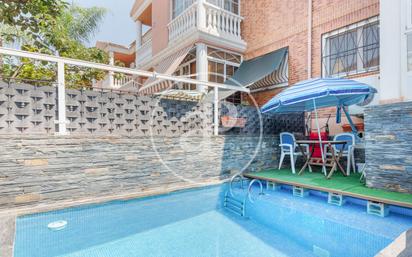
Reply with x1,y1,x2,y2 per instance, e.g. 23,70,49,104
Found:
99,0,412,132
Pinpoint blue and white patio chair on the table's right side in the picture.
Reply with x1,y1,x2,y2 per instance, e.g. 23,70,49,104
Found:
324,133,356,176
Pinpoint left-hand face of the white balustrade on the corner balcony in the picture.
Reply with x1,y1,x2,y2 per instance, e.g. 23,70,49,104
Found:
167,2,198,41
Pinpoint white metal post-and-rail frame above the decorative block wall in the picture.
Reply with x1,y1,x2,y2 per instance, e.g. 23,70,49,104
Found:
0,47,250,135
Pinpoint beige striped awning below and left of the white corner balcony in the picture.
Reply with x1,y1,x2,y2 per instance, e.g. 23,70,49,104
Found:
140,45,193,95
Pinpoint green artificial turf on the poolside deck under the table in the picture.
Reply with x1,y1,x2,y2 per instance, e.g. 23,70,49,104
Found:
245,169,412,205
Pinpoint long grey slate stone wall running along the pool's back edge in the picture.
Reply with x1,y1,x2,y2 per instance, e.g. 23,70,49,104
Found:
0,136,279,210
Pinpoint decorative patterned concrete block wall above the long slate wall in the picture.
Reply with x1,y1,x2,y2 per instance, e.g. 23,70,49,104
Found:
0,82,304,136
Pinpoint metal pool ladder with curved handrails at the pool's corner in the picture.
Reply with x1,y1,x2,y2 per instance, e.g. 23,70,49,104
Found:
223,174,263,217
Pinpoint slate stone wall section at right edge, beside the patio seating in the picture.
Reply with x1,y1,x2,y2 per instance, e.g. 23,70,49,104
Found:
365,102,412,193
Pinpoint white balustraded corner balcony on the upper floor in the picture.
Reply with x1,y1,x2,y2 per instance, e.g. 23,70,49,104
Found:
168,1,246,50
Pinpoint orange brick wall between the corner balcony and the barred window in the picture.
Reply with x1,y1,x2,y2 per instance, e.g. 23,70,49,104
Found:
241,0,379,104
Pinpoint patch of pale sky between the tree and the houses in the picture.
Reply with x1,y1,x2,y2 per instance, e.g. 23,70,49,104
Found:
69,0,136,46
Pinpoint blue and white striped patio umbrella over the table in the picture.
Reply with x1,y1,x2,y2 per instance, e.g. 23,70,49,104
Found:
261,78,377,172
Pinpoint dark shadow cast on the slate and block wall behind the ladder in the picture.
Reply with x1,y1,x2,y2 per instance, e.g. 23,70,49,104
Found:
220,103,305,175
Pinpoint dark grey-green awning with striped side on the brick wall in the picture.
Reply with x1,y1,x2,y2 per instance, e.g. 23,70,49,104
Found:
225,47,289,92
